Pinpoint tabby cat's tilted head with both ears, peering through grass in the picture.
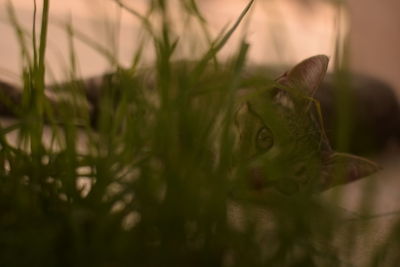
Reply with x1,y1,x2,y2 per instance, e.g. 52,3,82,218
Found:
235,55,380,194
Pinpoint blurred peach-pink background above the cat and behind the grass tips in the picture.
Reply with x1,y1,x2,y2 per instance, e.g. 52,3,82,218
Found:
0,0,400,96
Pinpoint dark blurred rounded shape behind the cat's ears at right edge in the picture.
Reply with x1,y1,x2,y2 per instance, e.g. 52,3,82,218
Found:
315,74,400,154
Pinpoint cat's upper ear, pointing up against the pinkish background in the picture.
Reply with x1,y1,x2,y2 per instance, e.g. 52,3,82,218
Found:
277,55,329,97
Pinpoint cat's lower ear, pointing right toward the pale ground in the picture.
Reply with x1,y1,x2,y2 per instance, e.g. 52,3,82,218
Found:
319,152,382,191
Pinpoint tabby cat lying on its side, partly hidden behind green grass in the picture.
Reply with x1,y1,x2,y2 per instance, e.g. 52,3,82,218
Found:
0,56,379,194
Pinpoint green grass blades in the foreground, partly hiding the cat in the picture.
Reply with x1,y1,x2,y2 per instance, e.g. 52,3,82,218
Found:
0,0,398,266
